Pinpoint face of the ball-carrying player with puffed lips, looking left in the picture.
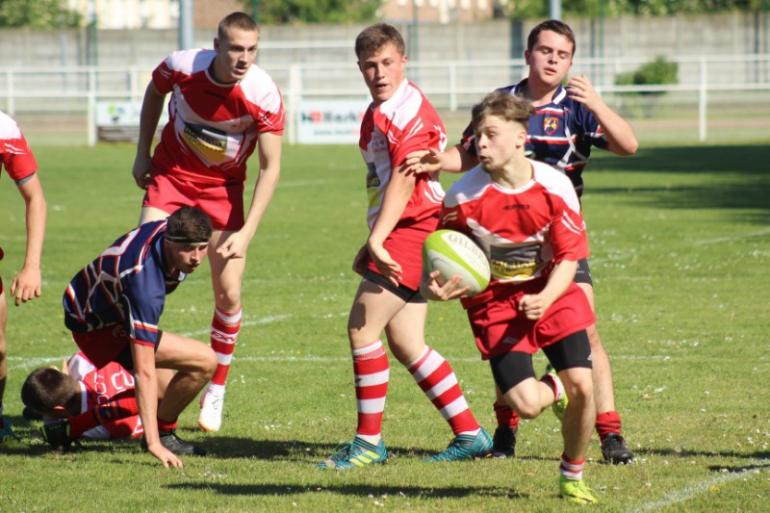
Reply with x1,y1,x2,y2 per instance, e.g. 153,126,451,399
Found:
476,115,527,172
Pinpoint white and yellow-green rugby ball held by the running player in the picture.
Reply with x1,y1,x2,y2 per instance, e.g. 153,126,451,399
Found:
422,230,490,296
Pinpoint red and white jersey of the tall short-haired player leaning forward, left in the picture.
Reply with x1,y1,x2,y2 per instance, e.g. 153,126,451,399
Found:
152,49,284,185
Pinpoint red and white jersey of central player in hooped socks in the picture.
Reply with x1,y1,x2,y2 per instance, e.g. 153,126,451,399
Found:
359,80,446,228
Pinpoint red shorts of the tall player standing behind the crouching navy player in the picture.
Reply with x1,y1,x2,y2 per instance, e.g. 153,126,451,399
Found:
142,174,243,231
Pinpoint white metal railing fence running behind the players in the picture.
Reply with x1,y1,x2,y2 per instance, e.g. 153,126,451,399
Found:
0,54,770,145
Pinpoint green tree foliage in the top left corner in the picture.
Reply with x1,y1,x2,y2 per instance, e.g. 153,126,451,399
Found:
0,0,80,28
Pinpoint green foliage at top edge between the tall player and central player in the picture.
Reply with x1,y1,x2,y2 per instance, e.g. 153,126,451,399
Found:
243,0,382,23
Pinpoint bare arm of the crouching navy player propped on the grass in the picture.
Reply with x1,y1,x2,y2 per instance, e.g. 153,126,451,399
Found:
131,340,184,468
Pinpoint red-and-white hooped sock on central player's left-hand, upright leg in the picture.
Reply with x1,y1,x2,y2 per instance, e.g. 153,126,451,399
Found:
352,340,390,445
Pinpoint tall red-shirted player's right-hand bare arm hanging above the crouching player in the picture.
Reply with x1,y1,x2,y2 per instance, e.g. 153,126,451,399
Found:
217,132,282,258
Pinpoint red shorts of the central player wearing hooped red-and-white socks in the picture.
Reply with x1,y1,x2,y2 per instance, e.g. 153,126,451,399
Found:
366,215,438,290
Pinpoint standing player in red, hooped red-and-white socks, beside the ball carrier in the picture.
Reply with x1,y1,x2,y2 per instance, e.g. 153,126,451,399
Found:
320,23,492,469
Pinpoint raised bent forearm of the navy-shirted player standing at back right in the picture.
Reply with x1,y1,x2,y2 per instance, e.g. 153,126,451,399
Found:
567,76,639,155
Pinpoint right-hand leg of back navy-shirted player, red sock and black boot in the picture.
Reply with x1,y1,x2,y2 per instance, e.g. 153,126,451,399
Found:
578,283,634,463
